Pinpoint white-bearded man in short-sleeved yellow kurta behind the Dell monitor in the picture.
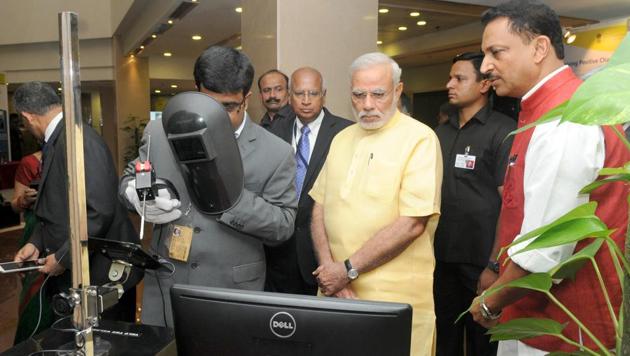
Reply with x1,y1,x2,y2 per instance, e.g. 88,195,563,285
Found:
310,53,442,356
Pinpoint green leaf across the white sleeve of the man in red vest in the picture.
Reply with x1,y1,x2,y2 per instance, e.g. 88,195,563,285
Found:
512,216,612,256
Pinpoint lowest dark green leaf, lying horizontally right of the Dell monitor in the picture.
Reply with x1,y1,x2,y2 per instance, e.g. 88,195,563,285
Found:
488,318,567,341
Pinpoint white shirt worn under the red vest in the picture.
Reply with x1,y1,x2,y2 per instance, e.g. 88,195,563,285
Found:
508,66,606,273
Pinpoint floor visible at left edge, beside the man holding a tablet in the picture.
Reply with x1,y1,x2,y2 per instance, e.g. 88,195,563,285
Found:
0,225,22,352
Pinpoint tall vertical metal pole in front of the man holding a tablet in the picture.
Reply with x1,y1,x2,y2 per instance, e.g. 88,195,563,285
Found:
59,12,94,355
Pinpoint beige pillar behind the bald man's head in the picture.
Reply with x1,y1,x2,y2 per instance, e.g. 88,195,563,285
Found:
241,0,378,120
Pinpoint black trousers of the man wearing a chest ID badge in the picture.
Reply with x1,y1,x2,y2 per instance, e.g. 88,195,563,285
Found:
433,261,497,356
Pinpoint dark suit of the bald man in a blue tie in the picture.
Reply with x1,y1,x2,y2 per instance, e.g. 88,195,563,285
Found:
265,108,353,295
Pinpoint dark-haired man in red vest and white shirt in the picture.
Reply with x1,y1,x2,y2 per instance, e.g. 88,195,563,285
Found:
471,0,630,355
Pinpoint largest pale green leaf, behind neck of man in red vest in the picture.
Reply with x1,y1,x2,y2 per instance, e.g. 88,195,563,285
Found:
561,63,630,125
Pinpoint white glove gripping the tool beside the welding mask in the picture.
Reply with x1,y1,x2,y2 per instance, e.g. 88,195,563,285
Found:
125,179,182,224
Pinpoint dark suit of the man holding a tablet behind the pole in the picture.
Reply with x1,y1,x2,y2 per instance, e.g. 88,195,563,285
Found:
30,120,142,321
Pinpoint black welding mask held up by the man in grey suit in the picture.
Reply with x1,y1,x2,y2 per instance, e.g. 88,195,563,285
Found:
162,92,243,214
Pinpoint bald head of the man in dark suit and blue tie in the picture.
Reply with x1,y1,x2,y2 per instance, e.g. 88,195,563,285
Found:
291,67,326,124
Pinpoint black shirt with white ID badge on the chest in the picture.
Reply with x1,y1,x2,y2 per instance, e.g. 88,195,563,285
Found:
435,105,516,267
